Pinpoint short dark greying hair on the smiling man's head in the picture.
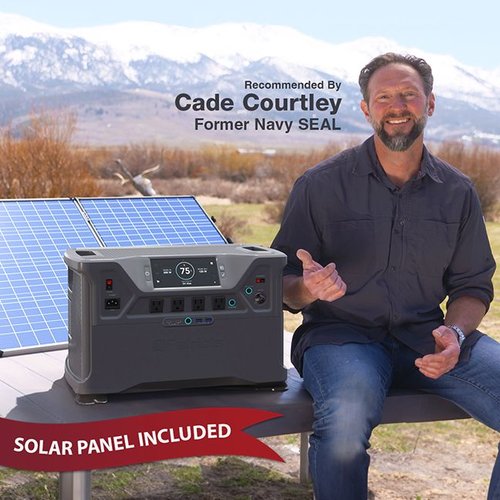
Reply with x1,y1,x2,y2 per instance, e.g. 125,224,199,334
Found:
358,52,434,102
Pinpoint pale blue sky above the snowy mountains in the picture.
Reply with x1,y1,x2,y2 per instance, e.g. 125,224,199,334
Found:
0,0,500,69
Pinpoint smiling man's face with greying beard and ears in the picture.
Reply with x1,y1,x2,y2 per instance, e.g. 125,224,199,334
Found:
361,64,435,151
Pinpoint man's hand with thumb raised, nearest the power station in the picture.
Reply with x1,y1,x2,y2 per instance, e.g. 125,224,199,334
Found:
297,249,347,302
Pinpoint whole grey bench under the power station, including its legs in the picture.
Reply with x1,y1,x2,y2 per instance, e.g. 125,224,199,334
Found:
0,351,469,500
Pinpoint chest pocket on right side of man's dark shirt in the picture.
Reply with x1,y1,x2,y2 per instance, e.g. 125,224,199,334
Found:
406,220,459,277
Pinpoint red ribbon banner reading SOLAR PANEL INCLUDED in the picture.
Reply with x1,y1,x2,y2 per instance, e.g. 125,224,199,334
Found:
0,408,283,472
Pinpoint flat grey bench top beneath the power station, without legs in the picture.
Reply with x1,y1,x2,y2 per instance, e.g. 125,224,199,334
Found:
0,350,312,435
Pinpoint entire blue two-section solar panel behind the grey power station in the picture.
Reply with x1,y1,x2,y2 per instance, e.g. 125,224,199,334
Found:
0,196,226,355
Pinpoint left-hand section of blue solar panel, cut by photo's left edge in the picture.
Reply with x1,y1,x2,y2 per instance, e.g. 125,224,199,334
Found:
0,199,98,352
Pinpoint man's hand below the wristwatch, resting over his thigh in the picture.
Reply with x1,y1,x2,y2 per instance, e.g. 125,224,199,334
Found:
415,325,460,379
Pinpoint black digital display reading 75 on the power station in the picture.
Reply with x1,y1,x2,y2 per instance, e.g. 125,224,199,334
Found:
151,257,220,288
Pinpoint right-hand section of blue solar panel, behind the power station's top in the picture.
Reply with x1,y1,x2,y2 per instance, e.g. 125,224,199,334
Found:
79,196,226,247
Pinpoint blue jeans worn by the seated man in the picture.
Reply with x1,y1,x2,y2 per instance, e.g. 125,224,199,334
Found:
303,336,500,500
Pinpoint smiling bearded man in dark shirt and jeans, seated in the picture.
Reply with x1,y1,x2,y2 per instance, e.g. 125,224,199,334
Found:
273,53,500,500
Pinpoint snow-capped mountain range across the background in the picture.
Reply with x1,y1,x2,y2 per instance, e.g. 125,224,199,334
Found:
0,14,500,143
